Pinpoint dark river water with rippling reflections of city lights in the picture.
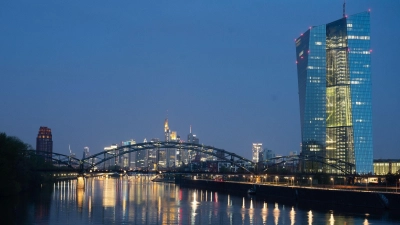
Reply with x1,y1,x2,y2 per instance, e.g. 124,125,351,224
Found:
5,177,400,225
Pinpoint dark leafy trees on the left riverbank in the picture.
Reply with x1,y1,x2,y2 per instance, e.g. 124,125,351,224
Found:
0,133,53,197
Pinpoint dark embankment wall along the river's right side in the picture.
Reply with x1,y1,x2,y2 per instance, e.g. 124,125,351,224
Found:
175,177,400,211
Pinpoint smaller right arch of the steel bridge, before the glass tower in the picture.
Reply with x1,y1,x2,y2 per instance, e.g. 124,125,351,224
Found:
263,155,355,175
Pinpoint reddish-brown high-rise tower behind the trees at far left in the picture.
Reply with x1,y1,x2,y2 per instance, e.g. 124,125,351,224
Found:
36,127,53,162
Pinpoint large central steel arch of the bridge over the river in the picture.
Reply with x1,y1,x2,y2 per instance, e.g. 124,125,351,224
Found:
80,142,254,173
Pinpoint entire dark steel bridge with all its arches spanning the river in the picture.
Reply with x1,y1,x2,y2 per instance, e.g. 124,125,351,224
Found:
27,142,356,175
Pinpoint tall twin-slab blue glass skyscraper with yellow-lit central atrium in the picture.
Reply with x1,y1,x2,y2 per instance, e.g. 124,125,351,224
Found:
296,12,373,174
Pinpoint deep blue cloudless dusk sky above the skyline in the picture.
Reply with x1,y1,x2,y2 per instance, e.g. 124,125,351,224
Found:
0,0,400,159
